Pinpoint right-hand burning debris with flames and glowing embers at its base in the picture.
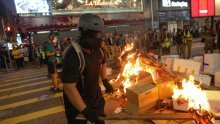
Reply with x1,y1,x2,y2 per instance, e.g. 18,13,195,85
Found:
172,76,214,124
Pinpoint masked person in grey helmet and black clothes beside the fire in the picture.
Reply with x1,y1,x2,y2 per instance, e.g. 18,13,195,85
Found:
61,13,113,124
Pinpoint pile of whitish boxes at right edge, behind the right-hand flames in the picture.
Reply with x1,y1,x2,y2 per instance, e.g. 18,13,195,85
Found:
161,53,220,87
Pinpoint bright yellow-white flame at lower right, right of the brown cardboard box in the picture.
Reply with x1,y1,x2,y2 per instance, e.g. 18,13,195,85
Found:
172,76,211,112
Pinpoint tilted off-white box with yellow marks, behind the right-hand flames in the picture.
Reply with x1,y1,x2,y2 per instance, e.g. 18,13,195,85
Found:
173,59,201,74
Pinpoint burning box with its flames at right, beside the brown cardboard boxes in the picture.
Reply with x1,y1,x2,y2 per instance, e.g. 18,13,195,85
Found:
172,76,211,112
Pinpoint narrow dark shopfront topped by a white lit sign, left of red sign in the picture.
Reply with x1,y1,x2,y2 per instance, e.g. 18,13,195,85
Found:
158,0,190,31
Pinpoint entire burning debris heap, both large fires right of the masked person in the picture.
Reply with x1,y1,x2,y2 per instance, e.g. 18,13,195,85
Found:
107,44,214,124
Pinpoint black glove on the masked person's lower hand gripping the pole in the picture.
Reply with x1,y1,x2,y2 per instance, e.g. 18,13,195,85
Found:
81,107,100,123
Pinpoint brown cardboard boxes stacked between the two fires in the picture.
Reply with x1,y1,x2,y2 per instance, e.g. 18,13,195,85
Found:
125,74,174,113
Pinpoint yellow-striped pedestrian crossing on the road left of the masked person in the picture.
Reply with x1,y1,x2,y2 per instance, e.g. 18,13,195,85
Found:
0,68,66,124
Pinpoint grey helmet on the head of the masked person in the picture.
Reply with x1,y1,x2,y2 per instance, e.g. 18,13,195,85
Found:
79,13,104,32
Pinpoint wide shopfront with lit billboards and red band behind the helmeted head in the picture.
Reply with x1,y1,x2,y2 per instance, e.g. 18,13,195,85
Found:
15,0,148,32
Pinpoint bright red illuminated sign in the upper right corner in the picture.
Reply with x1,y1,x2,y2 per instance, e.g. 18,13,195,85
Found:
191,0,215,17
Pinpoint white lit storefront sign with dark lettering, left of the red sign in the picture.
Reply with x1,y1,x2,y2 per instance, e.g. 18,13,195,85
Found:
162,0,188,7
